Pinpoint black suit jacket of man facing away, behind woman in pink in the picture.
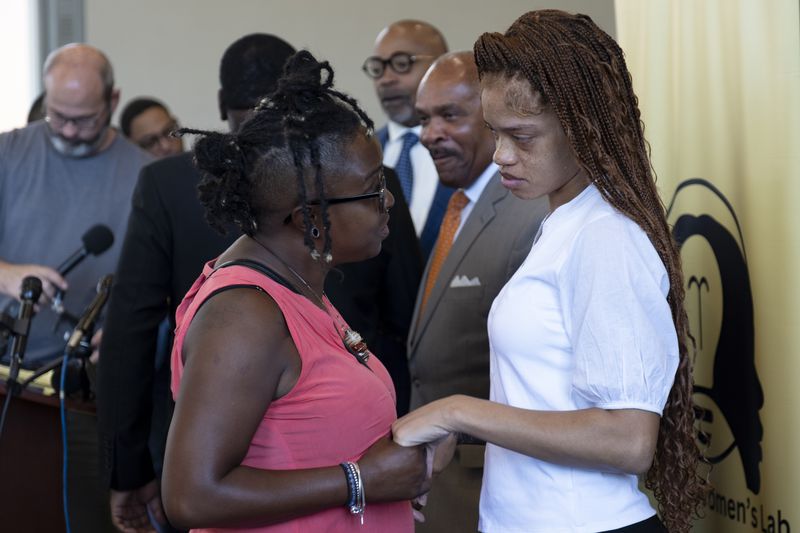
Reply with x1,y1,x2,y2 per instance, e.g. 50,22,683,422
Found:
97,154,422,490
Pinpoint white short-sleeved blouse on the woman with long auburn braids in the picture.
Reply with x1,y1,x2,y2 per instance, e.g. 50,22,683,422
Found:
479,185,678,533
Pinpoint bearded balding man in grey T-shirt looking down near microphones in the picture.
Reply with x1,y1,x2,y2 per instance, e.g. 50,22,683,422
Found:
0,44,151,532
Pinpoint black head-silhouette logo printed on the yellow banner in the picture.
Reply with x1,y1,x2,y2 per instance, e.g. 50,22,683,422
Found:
667,178,764,494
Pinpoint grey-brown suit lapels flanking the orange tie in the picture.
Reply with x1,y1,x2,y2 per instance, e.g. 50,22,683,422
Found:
409,173,509,355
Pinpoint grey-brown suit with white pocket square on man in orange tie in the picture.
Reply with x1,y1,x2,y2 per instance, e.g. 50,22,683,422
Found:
408,174,547,532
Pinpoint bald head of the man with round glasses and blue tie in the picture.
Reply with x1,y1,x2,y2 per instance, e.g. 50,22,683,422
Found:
368,20,447,127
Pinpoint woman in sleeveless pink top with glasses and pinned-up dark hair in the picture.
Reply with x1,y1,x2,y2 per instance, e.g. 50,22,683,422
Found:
163,52,430,533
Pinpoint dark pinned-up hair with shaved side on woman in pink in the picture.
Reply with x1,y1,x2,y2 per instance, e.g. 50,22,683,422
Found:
178,50,373,262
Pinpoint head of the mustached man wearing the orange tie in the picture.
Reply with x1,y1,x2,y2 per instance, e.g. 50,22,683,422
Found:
416,52,494,188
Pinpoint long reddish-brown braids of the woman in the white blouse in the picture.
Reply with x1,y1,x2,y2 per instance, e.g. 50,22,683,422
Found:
474,10,707,532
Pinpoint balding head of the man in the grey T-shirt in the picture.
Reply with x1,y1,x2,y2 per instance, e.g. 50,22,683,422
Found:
42,44,119,157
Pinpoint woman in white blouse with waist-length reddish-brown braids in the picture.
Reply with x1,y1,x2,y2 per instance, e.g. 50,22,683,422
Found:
393,10,705,533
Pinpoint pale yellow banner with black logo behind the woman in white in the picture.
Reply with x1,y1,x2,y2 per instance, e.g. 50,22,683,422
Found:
615,0,800,533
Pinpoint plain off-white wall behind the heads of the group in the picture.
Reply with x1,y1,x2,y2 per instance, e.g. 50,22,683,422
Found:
85,0,615,129
